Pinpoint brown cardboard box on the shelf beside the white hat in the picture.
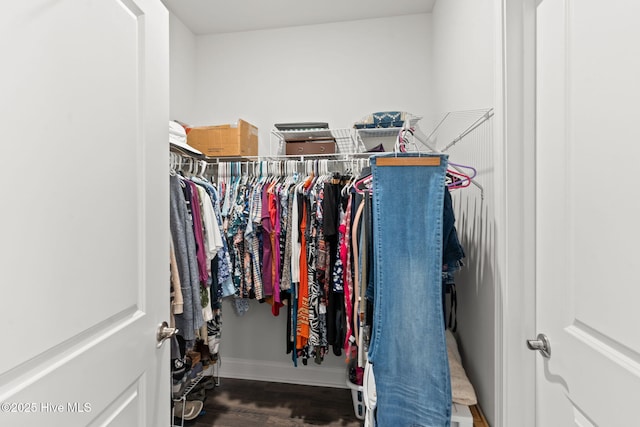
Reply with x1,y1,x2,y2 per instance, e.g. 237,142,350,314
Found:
187,119,258,157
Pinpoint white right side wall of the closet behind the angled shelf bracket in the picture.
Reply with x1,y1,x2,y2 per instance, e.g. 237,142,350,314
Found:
432,0,500,425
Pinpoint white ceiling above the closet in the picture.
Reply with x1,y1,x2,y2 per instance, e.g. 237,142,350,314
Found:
162,0,436,34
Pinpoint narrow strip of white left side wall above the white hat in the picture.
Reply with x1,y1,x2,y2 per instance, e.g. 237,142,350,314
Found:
169,13,196,123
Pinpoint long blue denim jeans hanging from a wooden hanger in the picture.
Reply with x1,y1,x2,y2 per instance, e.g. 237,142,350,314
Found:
368,153,451,427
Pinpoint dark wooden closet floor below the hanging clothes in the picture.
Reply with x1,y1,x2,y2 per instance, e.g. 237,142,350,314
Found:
180,378,488,427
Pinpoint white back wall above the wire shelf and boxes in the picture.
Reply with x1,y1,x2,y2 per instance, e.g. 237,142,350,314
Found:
192,14,433,155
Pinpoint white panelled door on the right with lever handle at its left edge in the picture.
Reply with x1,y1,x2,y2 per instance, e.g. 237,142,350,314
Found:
536,0,640,427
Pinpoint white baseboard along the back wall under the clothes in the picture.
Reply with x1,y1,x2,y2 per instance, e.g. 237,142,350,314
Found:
220,357,347,388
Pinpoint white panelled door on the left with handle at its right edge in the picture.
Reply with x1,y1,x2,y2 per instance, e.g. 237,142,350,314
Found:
0,0,170,427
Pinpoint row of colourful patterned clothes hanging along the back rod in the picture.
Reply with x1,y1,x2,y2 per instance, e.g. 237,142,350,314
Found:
208,156,464,367
